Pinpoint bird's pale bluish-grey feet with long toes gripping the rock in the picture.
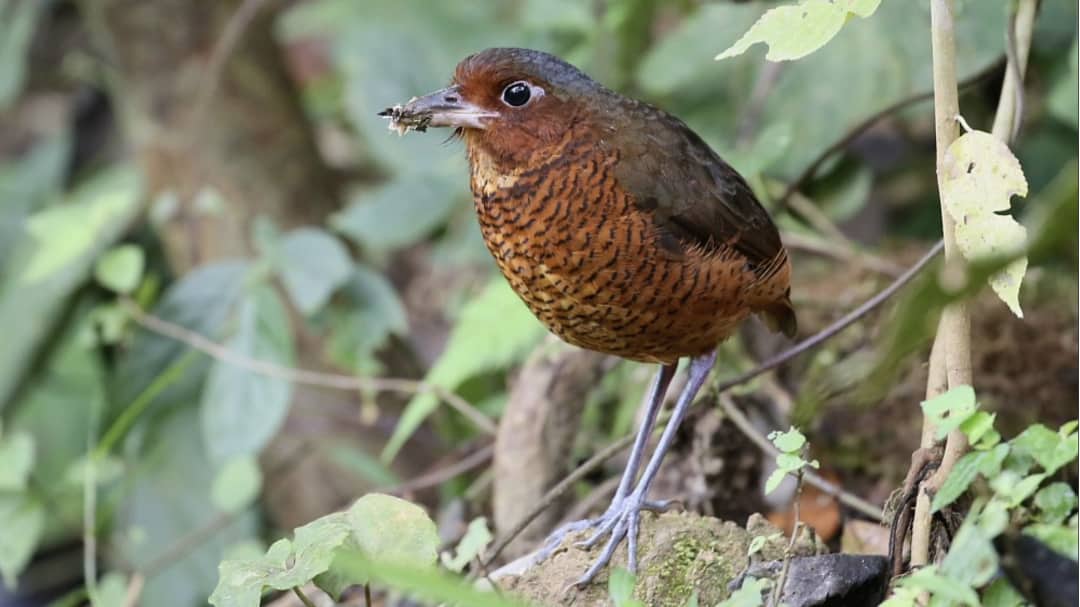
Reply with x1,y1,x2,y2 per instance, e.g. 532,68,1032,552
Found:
538,491,674,586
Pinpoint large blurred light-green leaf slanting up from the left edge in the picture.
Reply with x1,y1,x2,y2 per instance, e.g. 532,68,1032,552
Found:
0,170,139,408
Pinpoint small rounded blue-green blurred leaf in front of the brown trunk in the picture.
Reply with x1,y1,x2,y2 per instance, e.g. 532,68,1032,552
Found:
278,228,352,315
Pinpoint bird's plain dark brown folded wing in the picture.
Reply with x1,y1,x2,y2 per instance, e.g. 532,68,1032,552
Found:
604,102,786,280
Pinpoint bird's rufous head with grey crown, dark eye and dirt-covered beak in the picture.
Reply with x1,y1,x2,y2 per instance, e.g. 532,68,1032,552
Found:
384,49,609,162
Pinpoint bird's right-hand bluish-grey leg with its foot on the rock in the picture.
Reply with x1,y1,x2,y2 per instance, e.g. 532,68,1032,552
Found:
575,352,716,586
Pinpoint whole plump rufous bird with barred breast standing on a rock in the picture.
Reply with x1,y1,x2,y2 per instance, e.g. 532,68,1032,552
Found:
379,48,797,585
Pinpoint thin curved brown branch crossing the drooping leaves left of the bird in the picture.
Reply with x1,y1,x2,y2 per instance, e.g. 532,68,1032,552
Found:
120,298,496,435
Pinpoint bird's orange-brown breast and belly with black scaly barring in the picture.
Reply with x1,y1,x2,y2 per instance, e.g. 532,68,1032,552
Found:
469,132,786,364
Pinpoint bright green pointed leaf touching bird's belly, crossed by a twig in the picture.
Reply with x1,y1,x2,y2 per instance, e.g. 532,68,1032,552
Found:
382,278,544,461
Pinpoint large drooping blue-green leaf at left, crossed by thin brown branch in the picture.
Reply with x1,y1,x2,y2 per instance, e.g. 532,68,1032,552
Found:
201,285,293,461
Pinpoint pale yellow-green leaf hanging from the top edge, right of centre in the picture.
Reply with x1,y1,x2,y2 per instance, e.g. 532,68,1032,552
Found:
716,0,881,62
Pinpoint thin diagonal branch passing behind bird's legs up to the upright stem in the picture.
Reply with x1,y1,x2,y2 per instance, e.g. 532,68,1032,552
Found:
484,242,942,565
